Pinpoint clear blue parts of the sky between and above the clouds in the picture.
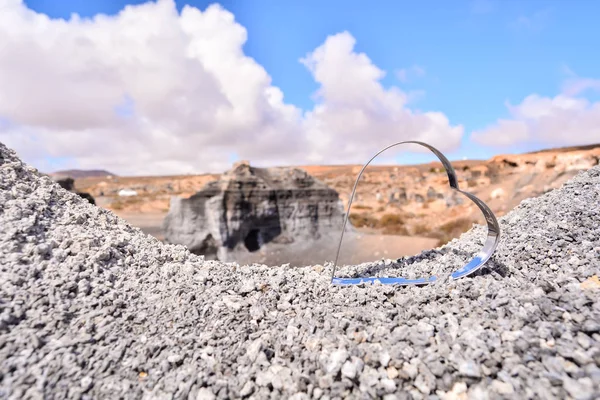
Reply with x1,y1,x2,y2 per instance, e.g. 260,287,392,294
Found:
4,0,600,173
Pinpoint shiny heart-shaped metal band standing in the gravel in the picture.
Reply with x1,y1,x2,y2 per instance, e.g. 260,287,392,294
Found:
331,141,500,286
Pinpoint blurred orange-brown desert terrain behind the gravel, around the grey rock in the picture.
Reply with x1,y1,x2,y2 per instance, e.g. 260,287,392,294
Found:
58,145,600,265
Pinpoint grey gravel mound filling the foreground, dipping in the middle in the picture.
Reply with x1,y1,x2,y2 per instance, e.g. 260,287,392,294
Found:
0,144,600,400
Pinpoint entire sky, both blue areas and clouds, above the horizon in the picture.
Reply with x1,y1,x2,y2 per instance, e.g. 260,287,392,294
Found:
0,0,600,175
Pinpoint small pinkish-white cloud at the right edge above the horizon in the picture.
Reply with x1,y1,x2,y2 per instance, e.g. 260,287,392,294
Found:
471,90,600,146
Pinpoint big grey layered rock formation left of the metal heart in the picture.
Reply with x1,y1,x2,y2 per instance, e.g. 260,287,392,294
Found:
163,162,344,260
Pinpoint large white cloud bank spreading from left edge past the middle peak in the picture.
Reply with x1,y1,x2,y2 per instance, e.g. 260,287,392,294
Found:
0,0,462,174
